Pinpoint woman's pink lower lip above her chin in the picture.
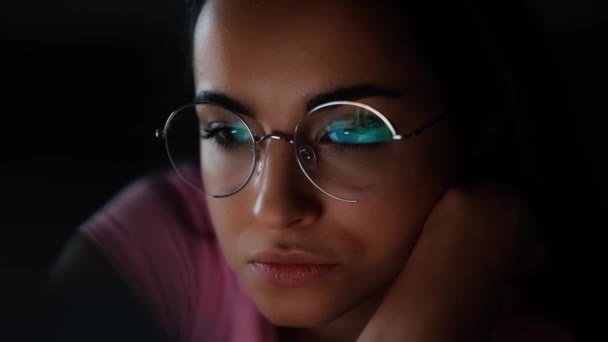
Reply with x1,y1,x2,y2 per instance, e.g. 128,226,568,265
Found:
251,262,336,287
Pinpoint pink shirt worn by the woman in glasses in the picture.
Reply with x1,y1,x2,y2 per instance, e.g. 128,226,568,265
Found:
80,173,573,342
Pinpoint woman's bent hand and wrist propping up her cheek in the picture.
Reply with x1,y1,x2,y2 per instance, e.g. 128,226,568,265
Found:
357,184,532,342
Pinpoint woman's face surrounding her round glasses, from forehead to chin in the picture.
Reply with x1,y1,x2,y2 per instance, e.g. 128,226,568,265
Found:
194,1,454,327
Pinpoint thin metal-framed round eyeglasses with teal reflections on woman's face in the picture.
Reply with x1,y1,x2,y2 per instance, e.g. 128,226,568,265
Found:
156,101,442,203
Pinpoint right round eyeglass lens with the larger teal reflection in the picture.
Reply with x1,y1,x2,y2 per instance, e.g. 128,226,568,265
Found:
294,102,398,201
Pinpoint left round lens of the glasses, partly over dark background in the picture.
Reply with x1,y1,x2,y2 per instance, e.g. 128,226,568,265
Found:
165,104,255,197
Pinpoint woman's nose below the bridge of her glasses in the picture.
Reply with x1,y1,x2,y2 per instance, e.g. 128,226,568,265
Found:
252,140,321,229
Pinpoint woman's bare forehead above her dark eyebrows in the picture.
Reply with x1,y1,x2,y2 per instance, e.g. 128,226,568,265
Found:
193,0,429,115
